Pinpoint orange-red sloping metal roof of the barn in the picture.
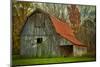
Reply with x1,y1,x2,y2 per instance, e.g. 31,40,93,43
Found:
50,16,86,47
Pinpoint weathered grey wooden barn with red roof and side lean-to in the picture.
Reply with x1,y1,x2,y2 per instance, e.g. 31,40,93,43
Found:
20,9,87,57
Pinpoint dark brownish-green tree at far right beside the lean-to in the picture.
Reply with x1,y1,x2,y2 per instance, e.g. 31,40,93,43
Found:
76,19,96,55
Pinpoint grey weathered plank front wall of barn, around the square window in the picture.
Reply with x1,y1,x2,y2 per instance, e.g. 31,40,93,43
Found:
21,14,61,57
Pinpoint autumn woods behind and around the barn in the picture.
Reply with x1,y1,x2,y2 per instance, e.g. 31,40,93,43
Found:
12,1,96,54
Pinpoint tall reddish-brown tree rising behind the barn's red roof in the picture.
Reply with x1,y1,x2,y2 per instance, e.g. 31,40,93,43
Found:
67,5,80,32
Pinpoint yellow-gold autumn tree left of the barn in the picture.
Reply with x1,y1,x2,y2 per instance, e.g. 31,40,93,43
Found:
12,0,33,54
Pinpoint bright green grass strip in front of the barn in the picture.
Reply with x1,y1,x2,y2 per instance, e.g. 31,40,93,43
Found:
12,56,96,66
